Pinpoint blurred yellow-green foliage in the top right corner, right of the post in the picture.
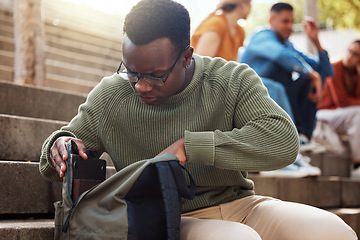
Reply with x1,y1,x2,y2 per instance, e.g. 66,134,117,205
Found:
318,0,360,31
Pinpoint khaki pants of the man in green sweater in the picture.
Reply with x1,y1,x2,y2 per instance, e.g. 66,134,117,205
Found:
180,195,357,240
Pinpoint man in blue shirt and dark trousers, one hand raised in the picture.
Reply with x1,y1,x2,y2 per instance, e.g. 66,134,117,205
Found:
240,3,333,138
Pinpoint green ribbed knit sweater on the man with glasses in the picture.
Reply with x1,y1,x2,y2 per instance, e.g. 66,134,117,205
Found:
40,55,299,212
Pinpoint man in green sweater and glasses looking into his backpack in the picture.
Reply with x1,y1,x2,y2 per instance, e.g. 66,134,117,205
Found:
40,0,356,240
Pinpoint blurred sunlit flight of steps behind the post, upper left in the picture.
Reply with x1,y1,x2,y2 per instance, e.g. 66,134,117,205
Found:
0,0,123,94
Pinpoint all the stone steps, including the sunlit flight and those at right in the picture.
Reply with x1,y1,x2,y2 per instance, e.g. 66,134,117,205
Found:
0,0,360,240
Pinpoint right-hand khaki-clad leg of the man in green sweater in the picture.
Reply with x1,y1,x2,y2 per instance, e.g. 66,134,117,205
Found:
220,196,357,240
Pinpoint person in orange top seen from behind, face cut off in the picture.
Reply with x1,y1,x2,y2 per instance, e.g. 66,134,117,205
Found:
191,0,251,61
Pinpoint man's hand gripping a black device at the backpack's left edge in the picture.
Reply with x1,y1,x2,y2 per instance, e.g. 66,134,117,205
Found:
50,137,88,178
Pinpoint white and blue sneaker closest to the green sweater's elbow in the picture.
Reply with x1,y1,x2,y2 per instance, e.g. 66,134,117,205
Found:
260,154,322,178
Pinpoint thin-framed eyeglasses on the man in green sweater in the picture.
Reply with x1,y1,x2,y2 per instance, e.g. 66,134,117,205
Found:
116,45,190,86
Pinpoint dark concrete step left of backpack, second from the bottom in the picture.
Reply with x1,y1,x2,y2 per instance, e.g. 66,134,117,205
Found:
0,160,116,214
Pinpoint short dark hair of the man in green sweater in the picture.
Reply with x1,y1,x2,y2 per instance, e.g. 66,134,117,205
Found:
123,0,190,54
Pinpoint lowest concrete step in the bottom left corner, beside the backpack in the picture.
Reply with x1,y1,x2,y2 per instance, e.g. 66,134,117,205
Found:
0,219,54,240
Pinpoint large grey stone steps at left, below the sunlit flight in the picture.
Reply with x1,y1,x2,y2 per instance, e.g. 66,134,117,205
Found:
0,81,115,239
